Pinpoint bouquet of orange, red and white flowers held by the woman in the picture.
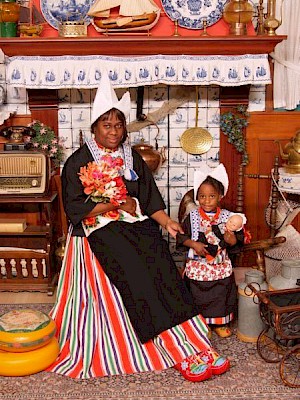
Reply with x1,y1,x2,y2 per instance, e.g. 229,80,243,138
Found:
79,154,127,206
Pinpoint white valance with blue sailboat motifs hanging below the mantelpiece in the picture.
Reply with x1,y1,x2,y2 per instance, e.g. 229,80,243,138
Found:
6,54,271,89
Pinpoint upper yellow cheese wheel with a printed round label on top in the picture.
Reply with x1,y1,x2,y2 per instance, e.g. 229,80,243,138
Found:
0,309,56,353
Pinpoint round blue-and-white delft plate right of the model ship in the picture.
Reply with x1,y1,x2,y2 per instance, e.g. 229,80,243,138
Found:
161,0,227,29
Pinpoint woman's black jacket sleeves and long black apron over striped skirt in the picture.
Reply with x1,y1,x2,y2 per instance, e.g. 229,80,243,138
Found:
62,145,199,343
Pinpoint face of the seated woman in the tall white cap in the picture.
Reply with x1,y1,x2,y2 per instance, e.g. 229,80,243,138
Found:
94,114,124,149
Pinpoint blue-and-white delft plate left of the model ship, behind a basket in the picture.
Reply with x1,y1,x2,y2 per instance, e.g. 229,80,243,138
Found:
40,0,94,29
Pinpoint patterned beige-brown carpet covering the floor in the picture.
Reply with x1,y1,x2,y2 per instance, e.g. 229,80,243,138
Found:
0,304,300,400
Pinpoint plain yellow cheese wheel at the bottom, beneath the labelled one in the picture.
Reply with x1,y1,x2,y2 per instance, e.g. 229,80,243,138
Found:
0,338,59,376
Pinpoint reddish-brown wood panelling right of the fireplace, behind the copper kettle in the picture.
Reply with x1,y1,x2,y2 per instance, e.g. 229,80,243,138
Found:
244,111,300,239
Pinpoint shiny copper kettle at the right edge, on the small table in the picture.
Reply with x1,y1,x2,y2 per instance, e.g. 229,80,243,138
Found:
276,130,300,174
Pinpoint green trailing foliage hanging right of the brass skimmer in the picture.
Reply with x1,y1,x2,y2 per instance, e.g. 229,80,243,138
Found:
220,105,249,165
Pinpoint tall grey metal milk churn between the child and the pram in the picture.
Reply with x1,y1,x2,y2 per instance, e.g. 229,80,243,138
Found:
237,269,268,342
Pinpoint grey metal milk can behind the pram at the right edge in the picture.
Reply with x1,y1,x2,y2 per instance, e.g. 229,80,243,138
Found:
269,259,300,290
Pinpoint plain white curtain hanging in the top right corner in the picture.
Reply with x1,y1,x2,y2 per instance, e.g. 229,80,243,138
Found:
271,0,300,110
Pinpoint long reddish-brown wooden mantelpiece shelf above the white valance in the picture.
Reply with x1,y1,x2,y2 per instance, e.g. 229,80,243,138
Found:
0,35,287,56
